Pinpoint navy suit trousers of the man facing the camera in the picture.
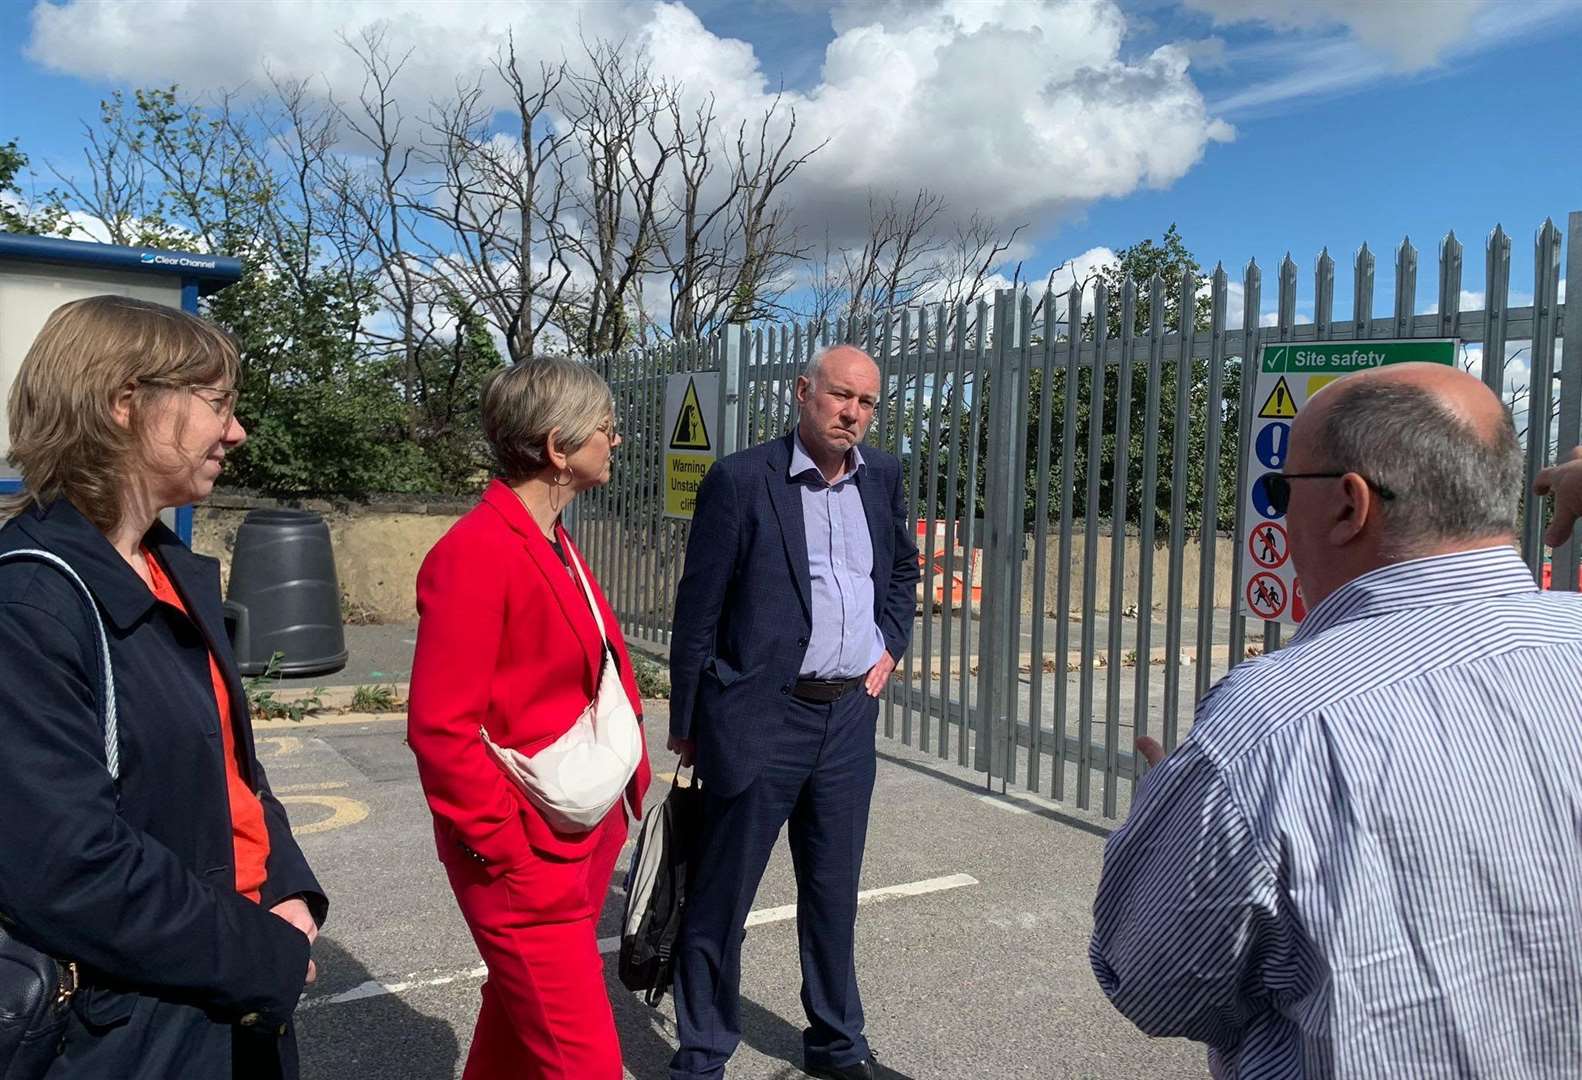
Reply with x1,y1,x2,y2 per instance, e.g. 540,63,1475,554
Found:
671,686,878,1080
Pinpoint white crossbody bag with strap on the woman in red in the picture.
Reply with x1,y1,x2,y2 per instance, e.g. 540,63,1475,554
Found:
478,540,642,833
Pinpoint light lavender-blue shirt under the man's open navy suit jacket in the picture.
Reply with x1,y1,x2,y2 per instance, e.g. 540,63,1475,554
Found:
789,433,884,678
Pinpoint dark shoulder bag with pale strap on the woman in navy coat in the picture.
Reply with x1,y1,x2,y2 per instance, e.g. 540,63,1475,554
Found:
0,549,120,1080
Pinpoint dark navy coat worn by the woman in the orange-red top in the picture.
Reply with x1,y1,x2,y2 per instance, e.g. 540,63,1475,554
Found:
0,500,326,1080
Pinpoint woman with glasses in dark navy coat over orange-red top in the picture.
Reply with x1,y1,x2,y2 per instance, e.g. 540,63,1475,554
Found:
0,296,326,1080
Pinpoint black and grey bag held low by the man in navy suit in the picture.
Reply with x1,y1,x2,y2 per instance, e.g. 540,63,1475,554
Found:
620,776,702,1006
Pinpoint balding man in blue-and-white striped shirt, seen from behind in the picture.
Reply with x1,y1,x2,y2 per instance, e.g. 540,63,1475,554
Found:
1092,365,1582,1080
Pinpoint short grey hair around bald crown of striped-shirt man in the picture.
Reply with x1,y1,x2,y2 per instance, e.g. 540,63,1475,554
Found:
1316,383,1522,558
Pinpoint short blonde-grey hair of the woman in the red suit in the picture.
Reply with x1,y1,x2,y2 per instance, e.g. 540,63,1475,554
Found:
483,356,615,484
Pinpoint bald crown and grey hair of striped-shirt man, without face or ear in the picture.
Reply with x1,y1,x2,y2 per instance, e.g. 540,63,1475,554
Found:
1291,364,1522,558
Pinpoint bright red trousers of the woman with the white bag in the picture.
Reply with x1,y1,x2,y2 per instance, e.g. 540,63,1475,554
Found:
445,802,626,1080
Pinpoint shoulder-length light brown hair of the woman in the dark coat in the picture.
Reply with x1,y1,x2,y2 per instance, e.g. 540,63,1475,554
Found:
0,296,242,533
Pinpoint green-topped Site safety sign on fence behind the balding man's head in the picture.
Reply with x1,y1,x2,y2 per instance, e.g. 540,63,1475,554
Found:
1237,337,1460,623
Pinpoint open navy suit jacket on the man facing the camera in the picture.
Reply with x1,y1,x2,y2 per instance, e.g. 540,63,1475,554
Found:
671,435,919,797
